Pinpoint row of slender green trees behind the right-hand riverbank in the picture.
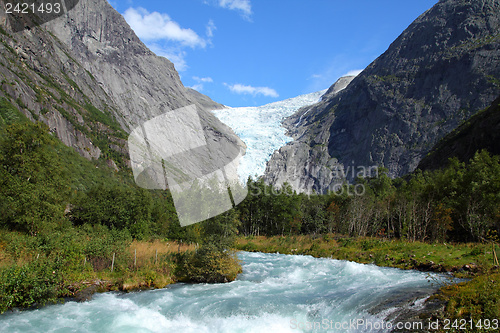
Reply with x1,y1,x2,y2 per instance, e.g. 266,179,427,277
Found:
237,151,500,242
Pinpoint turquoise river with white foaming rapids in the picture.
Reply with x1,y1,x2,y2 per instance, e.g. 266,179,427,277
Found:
0,252,458,333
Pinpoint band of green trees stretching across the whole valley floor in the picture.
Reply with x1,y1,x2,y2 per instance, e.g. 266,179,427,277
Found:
0,122,500,250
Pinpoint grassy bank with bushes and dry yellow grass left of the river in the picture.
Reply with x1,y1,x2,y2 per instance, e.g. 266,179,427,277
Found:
0,232,199,313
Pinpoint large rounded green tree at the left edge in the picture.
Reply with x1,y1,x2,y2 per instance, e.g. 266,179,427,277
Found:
0,122,70,235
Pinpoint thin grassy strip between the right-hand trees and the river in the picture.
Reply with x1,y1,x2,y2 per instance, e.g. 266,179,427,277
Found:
236,234,495,278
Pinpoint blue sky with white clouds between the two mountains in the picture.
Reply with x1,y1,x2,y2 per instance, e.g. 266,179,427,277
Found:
108,0,437,107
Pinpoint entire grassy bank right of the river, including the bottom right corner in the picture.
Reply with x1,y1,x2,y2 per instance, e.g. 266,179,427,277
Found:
236,234,500,324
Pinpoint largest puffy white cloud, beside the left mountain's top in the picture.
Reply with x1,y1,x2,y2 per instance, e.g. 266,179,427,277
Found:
123,8,207,48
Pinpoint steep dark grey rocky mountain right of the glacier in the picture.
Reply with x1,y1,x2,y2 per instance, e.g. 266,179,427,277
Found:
266,0,500,192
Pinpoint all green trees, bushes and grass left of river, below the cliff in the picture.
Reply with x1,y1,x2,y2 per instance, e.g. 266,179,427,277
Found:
0,114,241,313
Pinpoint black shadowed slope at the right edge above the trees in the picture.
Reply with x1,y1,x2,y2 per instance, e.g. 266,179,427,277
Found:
418,97,500,170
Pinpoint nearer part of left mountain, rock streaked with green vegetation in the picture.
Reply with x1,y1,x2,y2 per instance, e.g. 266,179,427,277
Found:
0,1,119,160
